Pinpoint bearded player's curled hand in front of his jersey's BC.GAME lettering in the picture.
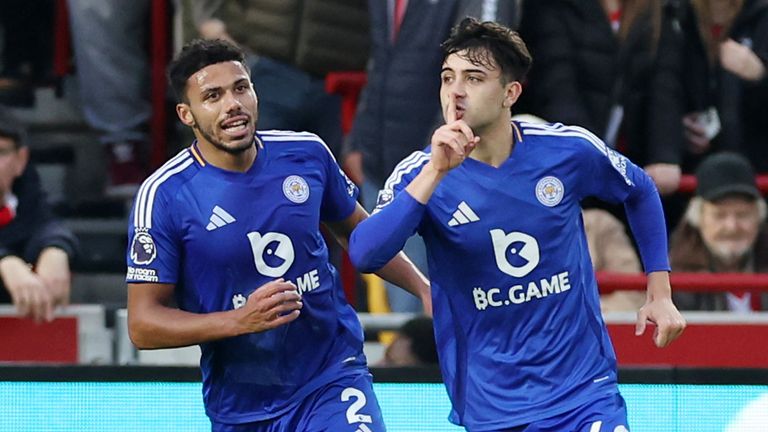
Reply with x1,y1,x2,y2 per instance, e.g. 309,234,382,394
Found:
237,278,303,333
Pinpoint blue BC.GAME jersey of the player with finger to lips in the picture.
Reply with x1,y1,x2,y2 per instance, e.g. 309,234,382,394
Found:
379,122,645,431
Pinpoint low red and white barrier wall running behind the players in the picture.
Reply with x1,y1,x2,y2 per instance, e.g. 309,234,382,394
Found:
0,302,768,368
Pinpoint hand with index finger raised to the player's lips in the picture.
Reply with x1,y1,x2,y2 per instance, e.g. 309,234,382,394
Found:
431,95,480,172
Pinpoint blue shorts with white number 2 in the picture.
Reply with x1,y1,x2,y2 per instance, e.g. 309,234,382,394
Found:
211,373,387,432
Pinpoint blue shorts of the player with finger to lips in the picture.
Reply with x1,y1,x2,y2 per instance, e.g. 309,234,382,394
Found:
498,393,629,432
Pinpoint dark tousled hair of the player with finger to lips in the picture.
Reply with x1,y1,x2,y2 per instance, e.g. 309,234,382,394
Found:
440,17,533,84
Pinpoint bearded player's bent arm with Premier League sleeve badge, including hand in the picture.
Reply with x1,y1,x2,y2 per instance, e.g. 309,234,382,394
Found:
126,174,302,349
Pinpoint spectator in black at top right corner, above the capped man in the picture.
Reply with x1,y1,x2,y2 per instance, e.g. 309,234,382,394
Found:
684,0,768,172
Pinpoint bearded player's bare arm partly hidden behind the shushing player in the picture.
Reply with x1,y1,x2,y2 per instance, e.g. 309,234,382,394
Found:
324,204,432,315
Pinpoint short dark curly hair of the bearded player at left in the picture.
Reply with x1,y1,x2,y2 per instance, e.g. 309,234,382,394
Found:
168,39,250,102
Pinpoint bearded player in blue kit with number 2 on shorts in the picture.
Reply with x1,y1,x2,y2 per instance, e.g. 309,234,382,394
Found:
127,41,429,432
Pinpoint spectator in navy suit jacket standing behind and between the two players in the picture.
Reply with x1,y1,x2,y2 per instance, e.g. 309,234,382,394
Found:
344,0,517,312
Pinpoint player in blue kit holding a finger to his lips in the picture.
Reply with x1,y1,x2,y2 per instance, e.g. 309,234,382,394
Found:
350,18,685,432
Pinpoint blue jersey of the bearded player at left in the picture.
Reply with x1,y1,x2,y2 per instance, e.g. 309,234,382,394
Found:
127,131,367,423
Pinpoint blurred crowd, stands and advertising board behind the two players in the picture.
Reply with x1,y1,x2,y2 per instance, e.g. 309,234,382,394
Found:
0,0,768,432
